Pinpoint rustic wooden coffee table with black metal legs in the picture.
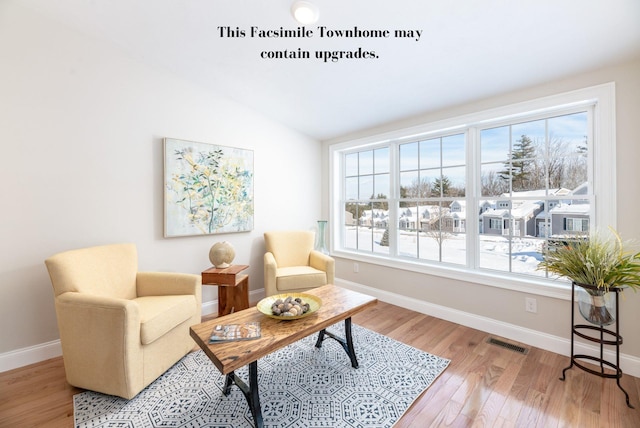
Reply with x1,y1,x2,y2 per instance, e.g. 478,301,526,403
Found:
191,285,377,427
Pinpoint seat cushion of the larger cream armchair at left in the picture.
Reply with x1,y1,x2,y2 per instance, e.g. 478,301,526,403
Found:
139,295,196,345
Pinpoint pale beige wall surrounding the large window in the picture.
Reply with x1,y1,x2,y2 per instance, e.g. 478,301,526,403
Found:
323,60,640,368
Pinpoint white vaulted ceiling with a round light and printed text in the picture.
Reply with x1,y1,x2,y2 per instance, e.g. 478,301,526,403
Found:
17,0,640,140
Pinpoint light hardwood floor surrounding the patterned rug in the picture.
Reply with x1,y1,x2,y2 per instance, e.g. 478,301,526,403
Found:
0,302,640,428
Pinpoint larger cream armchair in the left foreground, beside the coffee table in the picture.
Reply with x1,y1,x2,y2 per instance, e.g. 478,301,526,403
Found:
45,244,202,399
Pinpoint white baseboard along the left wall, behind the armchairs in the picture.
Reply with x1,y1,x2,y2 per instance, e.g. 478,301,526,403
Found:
0,290,264,373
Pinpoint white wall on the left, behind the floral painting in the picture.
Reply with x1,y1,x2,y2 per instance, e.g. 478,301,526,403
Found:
0,3,321,371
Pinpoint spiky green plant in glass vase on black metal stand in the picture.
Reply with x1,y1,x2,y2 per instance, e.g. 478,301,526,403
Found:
538,230,640,326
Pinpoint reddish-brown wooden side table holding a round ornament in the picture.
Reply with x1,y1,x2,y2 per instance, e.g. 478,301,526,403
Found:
202,265,249,317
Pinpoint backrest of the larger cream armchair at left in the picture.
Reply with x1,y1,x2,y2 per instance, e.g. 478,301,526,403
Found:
45,244,138,299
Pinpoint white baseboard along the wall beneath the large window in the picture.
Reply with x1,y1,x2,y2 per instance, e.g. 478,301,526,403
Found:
335,278,640,377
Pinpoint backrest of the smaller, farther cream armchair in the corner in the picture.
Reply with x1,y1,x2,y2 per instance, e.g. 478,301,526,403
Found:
264,230,315,267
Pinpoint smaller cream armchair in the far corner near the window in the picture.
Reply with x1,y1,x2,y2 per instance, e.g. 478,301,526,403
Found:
264,230,335,296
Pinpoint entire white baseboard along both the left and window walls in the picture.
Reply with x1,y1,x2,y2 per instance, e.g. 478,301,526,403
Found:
0,284,640,377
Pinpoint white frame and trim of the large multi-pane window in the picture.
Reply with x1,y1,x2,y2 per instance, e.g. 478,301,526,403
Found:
328,82,617,299
